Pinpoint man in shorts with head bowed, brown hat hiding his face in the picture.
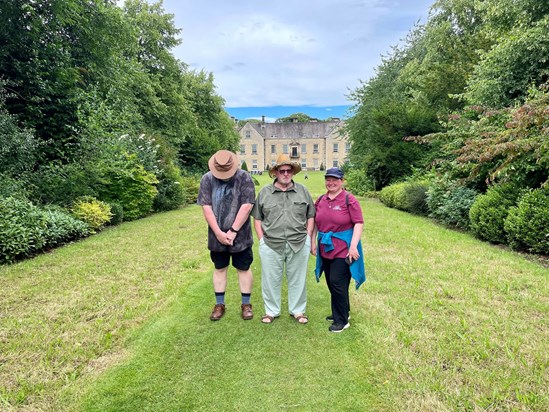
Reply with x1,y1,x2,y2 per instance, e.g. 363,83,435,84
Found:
197,150,255,321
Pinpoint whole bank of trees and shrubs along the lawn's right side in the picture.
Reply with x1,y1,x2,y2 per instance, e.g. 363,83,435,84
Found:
347,0,549,253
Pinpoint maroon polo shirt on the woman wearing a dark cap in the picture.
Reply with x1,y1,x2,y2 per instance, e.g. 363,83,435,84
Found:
315,190,364,259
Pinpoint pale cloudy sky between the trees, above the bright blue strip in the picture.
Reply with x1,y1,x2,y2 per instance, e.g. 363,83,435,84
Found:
146,0,434,115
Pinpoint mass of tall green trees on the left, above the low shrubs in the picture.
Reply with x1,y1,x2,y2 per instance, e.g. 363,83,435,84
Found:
0,0,238,192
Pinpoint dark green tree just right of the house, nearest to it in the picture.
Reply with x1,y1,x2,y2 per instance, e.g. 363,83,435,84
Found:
347,29,438,189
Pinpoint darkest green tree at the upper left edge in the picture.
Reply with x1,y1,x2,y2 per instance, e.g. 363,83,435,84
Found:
0,0,84,159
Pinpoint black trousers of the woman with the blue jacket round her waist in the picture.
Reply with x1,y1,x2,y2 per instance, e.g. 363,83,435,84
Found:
322,258,351,325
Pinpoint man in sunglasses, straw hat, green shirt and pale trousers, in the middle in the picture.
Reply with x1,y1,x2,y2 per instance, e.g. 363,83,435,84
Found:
252,154,315,324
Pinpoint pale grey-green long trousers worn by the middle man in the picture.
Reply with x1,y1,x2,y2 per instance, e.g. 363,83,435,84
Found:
259,236,311,317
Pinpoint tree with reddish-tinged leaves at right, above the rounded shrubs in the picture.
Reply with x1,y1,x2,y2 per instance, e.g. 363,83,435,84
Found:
412,90,549,191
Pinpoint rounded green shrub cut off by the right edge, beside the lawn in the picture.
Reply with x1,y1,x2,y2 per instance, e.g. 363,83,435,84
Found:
504,188,549,255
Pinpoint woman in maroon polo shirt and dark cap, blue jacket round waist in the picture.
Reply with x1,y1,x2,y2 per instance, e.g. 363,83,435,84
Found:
313,167,364,332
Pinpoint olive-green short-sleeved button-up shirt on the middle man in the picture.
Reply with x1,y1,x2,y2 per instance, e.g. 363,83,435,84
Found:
251,182,315,253
